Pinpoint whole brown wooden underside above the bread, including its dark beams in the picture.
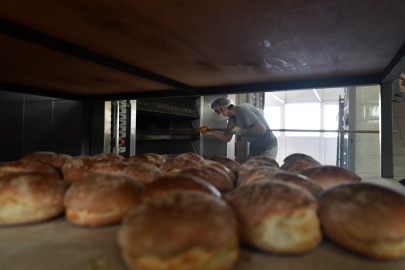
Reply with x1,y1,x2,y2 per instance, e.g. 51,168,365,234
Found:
0,0,405,100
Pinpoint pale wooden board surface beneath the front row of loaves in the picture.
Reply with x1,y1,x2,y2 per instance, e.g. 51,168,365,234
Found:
0,217,405,270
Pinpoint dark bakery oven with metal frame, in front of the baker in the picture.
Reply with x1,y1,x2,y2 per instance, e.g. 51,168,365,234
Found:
104,96,234,159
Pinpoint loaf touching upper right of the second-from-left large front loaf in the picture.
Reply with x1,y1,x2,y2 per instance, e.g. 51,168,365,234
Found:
116,162,164,184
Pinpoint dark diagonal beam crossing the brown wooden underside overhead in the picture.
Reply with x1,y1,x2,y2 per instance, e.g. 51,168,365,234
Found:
0,18,195,94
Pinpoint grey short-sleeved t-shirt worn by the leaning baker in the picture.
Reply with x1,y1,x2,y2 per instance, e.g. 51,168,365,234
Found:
225,103,277,156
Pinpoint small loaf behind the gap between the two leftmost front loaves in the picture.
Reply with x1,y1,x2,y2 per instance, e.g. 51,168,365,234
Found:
60,156,93,183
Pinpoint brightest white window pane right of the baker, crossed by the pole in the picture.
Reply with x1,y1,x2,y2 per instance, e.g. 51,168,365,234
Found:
285,103,321,137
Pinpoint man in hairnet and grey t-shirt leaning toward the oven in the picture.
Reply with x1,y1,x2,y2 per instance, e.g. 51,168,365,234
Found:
198,98,278,159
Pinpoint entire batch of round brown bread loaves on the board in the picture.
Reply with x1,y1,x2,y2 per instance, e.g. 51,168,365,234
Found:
0,152,405,270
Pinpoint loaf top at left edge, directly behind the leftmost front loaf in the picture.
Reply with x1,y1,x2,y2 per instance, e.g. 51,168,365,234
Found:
0,160,61,178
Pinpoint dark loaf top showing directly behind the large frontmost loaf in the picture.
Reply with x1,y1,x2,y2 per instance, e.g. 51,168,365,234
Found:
141,175,221,201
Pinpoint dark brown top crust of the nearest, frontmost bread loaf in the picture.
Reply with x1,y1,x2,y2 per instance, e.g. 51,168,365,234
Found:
118,191,238,257
